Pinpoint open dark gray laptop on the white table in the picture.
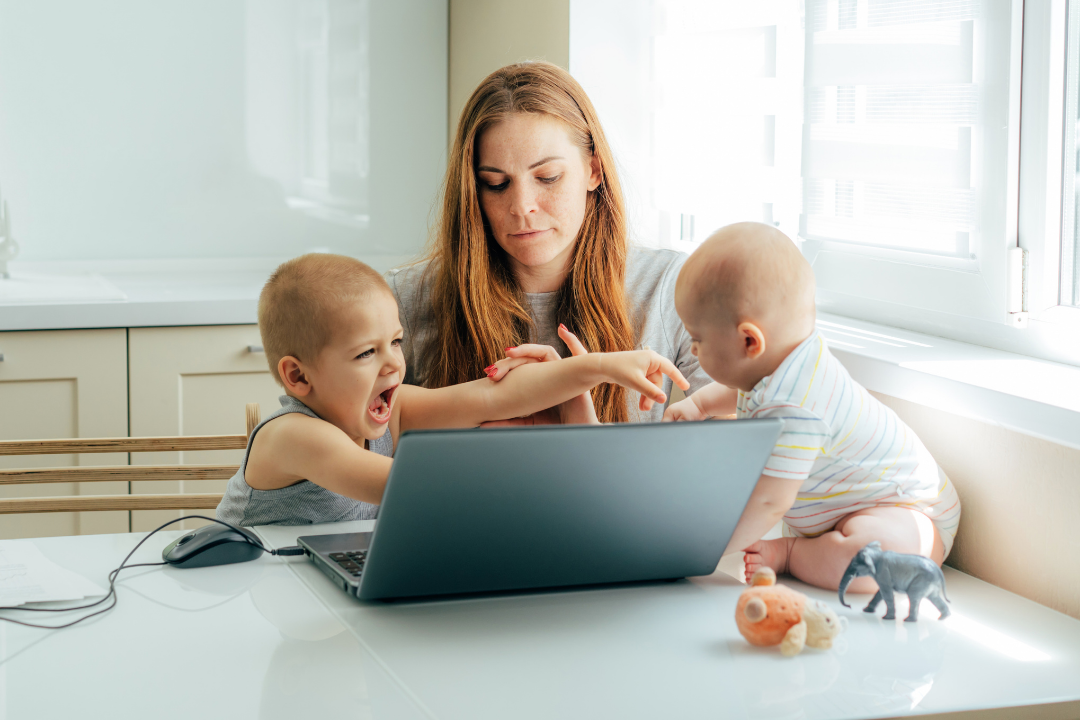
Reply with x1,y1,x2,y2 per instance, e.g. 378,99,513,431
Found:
297,420,783,600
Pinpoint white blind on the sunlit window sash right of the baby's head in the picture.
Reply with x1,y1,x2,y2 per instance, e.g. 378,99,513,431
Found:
799,0,983,258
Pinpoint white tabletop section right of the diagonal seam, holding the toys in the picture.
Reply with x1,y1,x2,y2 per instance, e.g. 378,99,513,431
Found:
258,521,1080,720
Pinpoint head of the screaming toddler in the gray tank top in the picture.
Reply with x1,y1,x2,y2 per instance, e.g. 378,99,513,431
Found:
259,254,405,439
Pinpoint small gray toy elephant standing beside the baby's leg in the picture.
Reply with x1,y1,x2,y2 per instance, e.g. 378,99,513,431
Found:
840,540,950,623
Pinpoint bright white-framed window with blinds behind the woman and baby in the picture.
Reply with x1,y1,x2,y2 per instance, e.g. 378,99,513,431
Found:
570,0,1080,363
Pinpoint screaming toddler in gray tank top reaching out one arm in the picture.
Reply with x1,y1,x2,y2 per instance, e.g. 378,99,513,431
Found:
217,255,689,526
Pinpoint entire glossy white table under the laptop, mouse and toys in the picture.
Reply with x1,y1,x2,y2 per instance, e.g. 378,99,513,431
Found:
6,522,1080,720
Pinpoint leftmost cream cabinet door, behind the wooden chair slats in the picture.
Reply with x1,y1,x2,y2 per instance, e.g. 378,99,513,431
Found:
0,329,129,539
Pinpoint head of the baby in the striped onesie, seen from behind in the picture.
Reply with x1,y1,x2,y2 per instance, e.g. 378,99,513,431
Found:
675,222,814,391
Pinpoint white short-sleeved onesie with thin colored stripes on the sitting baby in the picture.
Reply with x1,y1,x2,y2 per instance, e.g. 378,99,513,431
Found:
737,332,960,556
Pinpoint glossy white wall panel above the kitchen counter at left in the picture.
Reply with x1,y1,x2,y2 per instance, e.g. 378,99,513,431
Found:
0,0,448,260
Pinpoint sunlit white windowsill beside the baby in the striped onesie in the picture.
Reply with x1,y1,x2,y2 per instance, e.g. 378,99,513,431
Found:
818,313,1080,449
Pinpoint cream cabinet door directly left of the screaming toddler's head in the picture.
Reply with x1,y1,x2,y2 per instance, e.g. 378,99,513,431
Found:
129,325,282,531
